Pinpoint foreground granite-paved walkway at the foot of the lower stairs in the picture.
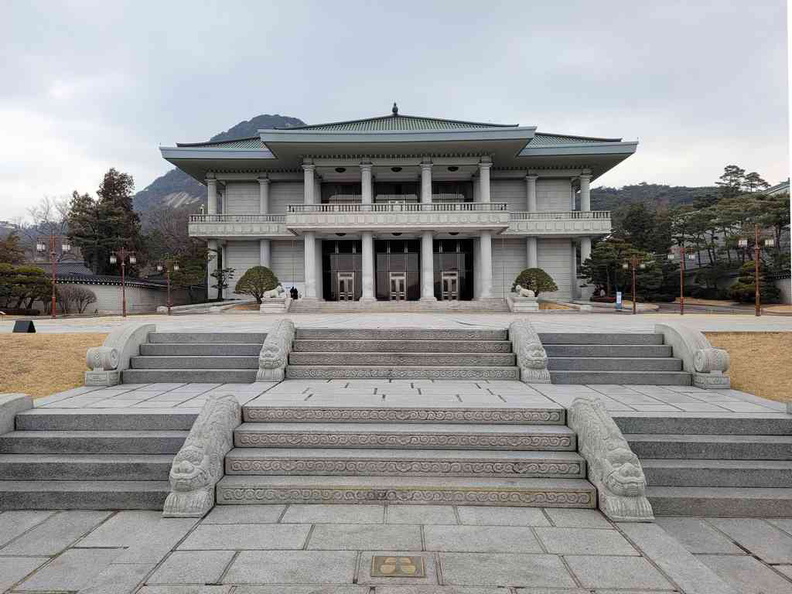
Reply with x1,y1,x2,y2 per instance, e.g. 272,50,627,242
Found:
0,505,792,594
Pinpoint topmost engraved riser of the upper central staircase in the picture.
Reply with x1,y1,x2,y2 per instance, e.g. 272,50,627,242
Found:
296,328,508,340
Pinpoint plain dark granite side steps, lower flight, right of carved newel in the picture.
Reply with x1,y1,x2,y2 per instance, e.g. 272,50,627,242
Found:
615,413,792,517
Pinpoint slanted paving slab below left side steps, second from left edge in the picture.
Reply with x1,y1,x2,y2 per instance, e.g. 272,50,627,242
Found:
0,511,111,556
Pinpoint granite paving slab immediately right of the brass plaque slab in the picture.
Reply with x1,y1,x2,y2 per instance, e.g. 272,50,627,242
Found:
439,553,575,588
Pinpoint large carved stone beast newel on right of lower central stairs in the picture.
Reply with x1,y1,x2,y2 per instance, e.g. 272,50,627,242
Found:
567,397,654,522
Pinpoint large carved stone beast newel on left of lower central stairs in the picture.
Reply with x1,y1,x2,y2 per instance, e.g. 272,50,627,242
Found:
162,394,242,518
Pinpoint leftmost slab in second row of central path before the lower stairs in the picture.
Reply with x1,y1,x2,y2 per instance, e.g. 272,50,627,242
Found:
179,524,311,551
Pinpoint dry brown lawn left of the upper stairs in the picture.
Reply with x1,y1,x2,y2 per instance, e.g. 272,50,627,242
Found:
0,332,107,398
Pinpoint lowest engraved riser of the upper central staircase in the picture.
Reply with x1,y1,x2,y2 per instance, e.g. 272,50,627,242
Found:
286,365,520,380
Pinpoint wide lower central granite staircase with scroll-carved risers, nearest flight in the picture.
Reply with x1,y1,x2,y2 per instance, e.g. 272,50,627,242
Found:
217,401,596,508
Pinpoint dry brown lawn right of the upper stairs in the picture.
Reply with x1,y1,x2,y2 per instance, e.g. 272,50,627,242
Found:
705,332,792,402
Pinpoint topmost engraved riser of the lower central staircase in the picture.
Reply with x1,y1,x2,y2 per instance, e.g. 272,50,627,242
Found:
242,406,566,425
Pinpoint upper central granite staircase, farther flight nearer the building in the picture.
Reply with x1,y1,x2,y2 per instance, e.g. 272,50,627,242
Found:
286,328,519,380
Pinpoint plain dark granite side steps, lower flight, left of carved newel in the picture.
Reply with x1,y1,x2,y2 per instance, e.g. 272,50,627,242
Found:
0,408,196,510
